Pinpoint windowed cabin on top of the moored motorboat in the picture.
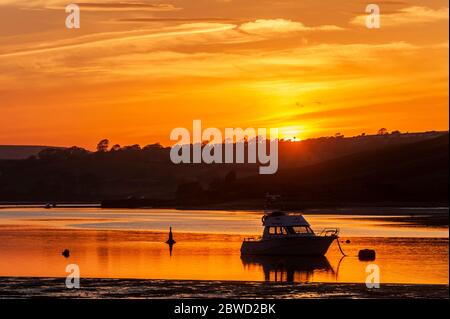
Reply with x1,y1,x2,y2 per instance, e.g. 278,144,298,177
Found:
262,211,315,238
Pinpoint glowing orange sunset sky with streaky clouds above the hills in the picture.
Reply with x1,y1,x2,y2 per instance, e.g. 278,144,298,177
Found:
0,0,449,149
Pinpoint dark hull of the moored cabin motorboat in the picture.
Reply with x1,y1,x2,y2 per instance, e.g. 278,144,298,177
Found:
241,236,336,256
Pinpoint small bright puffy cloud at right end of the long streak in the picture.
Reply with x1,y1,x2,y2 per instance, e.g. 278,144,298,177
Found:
239,19,342,34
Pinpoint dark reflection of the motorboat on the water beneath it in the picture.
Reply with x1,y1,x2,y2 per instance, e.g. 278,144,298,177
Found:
241,255,335,282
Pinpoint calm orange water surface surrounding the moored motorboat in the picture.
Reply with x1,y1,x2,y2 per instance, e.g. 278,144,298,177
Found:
0,208,448,284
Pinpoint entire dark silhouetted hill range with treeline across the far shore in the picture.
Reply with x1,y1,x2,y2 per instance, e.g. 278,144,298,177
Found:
0,132,449,208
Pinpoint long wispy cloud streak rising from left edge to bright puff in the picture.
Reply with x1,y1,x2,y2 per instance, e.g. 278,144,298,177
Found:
0,18,341,59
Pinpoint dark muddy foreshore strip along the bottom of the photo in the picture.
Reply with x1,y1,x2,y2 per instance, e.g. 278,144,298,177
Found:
0,277,449,299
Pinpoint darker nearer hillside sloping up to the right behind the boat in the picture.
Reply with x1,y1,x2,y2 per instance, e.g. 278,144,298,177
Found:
222,134,449,203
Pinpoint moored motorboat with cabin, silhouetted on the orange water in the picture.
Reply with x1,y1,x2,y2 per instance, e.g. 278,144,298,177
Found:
241,211,339,256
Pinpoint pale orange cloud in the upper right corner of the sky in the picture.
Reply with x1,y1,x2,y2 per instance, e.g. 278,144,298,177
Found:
351,6,449,27
